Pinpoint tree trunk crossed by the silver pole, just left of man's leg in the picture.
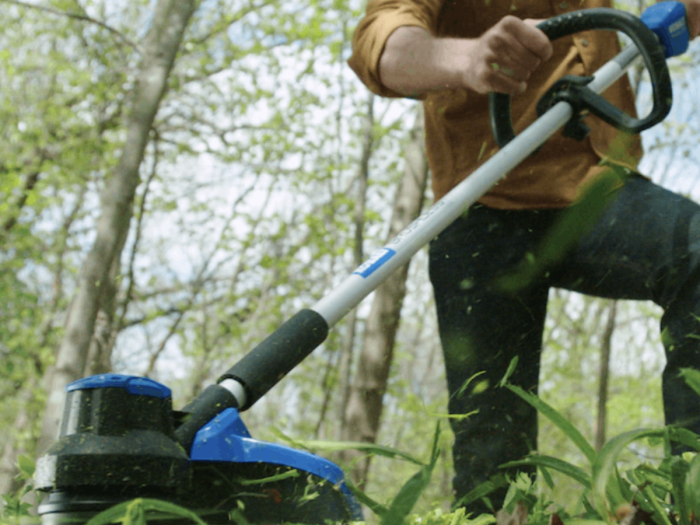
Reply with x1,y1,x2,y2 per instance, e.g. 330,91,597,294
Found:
343,108,428,486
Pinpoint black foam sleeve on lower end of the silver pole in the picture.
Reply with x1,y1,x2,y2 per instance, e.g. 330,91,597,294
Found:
219,310,328,410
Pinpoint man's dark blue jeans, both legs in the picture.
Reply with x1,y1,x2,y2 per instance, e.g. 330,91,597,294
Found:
430,176,700,512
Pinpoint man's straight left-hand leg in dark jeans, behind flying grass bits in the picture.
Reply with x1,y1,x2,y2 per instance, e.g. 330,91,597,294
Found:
430,206,554,514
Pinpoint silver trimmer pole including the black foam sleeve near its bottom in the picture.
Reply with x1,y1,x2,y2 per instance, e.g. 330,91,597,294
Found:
217,47,638,406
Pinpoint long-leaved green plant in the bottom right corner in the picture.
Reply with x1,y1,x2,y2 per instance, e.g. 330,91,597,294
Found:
461,370,700,525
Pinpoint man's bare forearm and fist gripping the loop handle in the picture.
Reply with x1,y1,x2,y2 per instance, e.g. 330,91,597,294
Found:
379,17,552,96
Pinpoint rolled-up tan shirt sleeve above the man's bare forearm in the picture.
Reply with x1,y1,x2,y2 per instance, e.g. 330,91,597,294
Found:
348,0,444,98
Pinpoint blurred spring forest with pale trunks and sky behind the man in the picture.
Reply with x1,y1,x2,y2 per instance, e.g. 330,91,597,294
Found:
0,0,700,508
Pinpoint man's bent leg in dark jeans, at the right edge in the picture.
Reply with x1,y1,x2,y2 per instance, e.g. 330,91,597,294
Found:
550,176,700,442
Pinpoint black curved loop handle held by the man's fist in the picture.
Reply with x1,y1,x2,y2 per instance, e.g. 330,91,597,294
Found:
489,7,673,148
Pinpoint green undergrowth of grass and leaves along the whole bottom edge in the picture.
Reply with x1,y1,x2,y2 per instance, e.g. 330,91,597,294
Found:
0,369,700,525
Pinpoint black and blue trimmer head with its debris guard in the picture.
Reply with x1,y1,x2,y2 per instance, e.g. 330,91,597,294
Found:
35,374,362,525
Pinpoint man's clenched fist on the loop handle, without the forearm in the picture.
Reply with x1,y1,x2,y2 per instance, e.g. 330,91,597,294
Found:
463,16,552,95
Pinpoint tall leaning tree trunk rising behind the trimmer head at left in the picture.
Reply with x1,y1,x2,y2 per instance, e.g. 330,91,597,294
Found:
37,0,196,453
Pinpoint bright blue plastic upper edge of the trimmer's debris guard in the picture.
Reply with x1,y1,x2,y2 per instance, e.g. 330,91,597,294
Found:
190,408,363,520
